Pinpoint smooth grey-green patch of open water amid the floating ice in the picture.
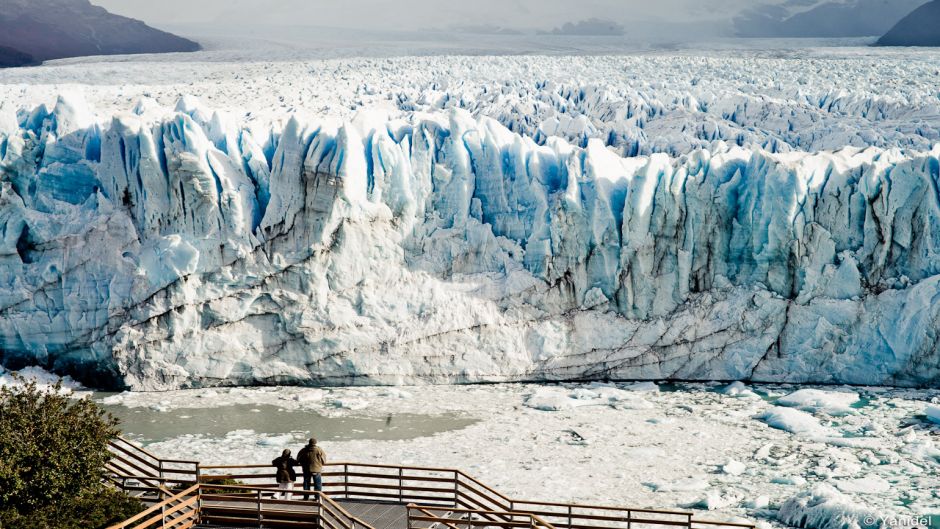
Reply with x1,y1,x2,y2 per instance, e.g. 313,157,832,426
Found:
95,394,478,444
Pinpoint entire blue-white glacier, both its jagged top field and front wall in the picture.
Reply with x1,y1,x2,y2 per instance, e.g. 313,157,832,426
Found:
0,50,940,390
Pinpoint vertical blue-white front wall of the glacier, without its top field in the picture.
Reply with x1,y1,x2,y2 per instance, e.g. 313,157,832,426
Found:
0,98,940,390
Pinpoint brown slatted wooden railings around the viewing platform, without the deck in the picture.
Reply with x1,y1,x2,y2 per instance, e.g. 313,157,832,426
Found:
108,439,754,529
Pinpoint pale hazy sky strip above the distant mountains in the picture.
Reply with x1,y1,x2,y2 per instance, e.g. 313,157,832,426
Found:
92,0,792,30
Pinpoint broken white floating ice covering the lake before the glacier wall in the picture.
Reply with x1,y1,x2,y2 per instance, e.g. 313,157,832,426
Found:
99,384,940,529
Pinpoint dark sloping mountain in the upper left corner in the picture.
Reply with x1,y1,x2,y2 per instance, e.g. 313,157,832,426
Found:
0,0,200,66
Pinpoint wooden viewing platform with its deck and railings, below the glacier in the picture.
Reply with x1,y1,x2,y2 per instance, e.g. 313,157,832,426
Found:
107,439,755,529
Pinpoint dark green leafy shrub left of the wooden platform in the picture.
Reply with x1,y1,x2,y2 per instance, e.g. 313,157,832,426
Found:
0,374,142,529
